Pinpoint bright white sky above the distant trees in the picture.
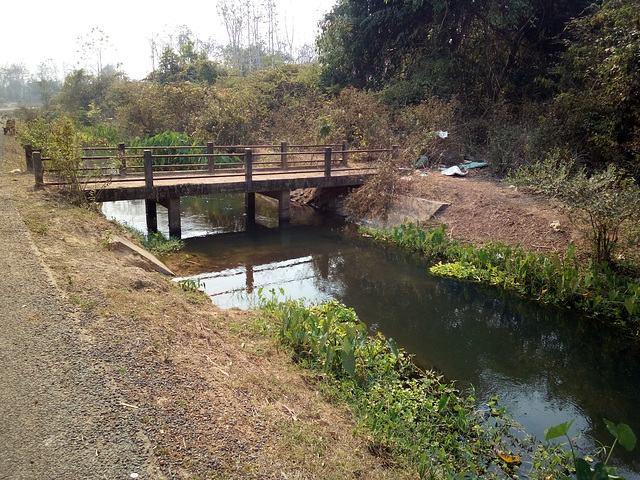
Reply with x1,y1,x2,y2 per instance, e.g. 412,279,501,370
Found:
0,0,337,79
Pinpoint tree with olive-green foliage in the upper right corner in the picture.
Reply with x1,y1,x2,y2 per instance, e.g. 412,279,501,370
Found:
549,0,640,174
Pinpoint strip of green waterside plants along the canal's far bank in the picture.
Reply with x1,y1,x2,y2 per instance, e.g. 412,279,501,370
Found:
363,222,640,336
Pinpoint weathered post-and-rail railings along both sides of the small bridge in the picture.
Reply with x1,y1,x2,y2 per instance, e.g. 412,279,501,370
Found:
31,142,398,187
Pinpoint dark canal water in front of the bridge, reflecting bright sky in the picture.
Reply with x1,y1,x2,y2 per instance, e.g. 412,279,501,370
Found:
106,198,640,478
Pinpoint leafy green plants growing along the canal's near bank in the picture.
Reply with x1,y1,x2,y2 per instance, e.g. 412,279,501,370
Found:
259,291,528,478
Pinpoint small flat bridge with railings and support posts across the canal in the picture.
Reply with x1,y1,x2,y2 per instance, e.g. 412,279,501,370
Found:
26,142,398,238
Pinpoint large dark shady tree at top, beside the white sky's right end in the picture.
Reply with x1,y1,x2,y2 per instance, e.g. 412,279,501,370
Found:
318,0,589,103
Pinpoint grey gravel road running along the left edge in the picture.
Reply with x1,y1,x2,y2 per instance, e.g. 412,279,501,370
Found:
0,133,164,480
